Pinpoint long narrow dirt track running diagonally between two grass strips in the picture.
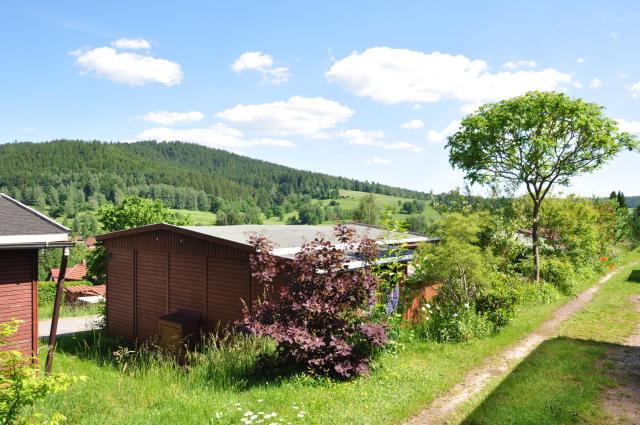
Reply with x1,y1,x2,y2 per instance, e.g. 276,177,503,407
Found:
405,269,620,425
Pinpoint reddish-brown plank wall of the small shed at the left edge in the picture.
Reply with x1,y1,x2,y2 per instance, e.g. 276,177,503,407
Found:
0,249,38,356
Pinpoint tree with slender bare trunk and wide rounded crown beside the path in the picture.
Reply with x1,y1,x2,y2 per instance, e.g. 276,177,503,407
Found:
447,92,638,280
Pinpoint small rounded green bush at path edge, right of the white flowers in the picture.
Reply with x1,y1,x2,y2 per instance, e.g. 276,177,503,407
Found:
476,280,520,331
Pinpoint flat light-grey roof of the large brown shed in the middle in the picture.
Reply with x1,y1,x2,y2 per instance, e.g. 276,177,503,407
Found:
180,224,430,249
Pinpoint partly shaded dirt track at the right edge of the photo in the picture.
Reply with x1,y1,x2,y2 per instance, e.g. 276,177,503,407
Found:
603,295,640,424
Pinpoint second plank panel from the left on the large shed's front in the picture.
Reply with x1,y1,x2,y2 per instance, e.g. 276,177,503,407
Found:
136,252,169,340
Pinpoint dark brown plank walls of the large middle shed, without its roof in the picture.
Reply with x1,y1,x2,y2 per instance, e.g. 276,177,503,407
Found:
105,230,251,341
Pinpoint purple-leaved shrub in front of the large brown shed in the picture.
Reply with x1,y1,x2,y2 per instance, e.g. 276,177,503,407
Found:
243,225,388,378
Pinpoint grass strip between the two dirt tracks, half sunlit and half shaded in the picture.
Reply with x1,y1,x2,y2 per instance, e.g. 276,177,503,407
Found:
463,251,640,425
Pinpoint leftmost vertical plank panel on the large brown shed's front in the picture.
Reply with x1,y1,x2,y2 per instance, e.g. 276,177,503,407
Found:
107,248,135,339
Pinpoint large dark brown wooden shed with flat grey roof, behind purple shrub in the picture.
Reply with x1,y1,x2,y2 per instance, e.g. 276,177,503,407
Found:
97,224,436,340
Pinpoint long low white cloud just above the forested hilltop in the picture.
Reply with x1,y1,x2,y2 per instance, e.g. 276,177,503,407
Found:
136,123,294,149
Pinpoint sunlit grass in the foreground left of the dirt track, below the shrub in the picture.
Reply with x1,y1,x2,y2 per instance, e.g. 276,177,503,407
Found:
30,254,640,425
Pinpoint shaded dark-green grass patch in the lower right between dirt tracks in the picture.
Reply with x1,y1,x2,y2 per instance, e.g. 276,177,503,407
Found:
462,337,640,425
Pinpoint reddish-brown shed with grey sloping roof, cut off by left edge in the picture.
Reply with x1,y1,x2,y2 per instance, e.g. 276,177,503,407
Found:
0,193,73,356
